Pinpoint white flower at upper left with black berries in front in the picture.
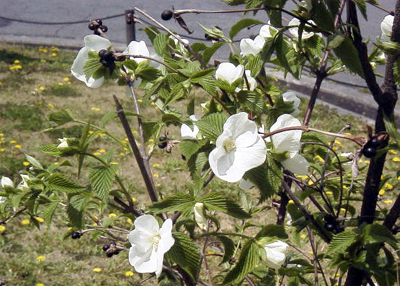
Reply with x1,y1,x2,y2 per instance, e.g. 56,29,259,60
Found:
71,35,111,88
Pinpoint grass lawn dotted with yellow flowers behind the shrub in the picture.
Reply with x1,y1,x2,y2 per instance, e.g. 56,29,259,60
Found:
0,44,400,286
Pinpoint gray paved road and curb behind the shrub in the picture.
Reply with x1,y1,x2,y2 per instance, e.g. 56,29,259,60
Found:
0,0,400,122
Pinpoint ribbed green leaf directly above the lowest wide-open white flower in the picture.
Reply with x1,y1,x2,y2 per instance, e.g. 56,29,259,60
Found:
150,193,196,214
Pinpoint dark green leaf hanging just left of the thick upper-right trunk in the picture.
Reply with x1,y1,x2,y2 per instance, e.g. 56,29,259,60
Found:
333,37,364,78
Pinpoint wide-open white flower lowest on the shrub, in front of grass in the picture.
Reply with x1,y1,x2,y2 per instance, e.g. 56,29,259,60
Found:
128,215,175,277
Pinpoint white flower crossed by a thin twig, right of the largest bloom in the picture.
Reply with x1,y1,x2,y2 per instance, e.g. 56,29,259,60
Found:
270,114,309,175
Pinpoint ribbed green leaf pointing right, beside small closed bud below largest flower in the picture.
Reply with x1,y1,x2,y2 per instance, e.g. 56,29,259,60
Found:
199,192,251,219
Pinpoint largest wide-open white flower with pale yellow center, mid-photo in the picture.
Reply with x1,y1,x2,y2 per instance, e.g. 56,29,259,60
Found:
209,112,266,182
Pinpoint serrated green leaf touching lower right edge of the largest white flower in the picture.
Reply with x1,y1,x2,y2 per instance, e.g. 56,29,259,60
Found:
244,155,283,202
